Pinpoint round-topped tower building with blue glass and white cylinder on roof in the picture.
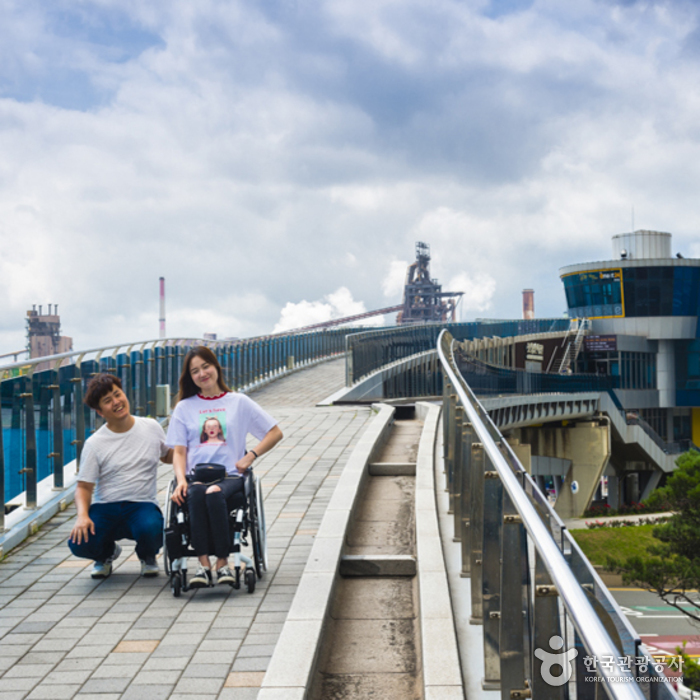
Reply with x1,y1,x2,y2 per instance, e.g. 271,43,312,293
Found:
559,231,700,445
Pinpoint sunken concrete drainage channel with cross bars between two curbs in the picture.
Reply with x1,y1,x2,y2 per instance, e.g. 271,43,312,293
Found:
307,407,423,700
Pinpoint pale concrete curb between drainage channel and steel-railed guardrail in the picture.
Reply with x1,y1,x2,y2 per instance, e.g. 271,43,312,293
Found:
416,402,464,700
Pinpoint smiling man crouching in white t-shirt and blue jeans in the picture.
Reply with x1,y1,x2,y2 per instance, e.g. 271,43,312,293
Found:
68,373,173,578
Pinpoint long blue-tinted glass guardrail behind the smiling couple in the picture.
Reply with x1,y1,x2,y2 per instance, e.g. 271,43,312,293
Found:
0,329,348,531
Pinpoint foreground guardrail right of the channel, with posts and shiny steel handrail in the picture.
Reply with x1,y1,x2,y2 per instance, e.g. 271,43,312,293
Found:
437,331,678,700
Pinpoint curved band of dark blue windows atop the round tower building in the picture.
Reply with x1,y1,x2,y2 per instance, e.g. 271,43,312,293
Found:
562,265,700,318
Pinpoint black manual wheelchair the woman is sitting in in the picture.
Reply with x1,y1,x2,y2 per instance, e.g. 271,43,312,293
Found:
163,469,267,598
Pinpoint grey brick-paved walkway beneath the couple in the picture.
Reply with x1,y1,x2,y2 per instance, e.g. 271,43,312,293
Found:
0,360,371,700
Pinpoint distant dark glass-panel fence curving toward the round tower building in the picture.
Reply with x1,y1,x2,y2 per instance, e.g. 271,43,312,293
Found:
345,318,571,386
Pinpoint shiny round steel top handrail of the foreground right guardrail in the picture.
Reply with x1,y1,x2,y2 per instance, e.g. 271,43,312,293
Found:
438,331,644,700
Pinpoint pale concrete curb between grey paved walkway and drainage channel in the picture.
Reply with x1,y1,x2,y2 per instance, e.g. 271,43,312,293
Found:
258,404,395,700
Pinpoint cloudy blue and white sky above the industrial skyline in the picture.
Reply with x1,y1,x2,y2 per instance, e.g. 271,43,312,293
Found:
0,0,700,352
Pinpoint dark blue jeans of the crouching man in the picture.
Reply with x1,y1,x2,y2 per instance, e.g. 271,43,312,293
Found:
68,501,163,561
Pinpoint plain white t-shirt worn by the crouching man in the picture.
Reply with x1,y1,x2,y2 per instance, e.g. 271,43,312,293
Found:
78,416,169,505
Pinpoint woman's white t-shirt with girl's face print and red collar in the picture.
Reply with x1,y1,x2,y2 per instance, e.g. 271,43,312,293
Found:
167,392,277,474
